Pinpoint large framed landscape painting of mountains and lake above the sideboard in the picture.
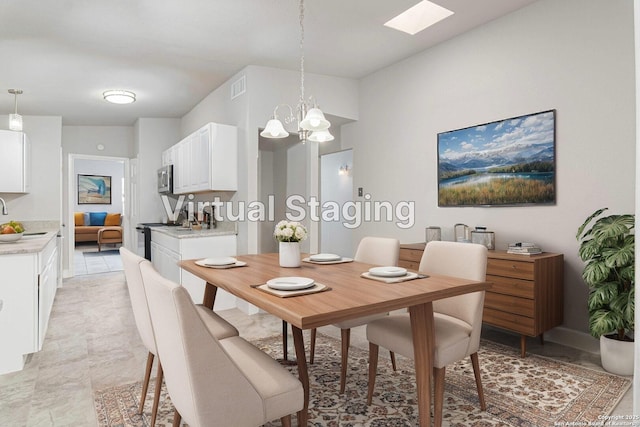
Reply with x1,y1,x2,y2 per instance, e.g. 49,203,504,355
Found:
438,110,556,207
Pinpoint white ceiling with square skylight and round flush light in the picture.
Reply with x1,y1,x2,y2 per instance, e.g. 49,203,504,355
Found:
0,0,537,127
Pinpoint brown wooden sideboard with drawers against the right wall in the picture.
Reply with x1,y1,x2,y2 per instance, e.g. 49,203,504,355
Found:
398,243,564,357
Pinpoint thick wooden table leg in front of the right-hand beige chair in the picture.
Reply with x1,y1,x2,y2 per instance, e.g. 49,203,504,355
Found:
409,302,435,427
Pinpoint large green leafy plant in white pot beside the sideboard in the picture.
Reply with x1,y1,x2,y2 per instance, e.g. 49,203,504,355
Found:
576,208,635,375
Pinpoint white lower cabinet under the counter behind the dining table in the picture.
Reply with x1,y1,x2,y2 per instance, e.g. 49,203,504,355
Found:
151,230,237,310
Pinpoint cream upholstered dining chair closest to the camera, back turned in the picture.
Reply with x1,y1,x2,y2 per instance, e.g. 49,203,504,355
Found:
140,263,304,427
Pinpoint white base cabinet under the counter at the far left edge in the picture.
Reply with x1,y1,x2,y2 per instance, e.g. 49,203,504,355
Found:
0,237,58,374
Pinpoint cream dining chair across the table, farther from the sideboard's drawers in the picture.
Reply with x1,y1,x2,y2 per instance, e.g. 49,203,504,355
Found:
309,236,400,394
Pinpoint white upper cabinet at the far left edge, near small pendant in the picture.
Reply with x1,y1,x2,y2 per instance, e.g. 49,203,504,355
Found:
0,130,31,193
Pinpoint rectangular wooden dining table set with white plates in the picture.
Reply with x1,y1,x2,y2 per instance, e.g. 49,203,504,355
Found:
180,253,490,426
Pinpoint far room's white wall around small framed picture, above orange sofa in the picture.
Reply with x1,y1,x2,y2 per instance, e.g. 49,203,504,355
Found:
73,159,124,214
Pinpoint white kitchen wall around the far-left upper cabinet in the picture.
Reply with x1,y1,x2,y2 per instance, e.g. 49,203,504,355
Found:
0,115,62,222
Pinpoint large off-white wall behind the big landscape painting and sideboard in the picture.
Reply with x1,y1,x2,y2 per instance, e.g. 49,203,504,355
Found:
342,0,635,332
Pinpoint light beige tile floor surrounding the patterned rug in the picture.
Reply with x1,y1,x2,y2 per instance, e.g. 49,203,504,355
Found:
0,272,632,427
